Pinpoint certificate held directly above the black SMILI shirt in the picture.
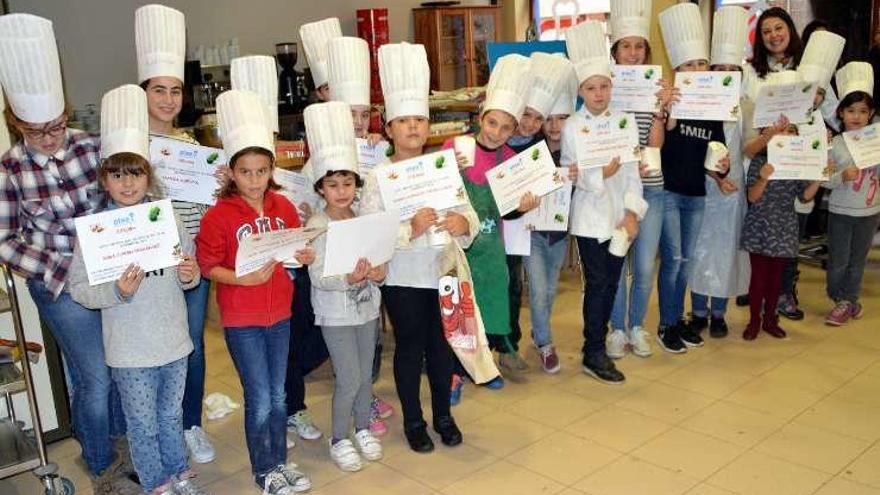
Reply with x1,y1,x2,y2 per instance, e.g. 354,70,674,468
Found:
670,72,742,120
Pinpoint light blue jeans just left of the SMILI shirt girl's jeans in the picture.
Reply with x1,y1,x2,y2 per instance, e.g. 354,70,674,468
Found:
611,186,665,330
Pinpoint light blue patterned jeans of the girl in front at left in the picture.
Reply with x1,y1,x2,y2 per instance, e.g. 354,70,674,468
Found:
111,358,189,492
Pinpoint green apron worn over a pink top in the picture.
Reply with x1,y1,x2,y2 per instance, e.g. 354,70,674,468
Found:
462,165,510,335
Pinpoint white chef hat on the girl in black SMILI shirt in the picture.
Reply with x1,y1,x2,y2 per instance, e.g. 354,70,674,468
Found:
659,3,709,67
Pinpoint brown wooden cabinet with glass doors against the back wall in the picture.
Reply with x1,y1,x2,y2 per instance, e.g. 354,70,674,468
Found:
413,6,501,90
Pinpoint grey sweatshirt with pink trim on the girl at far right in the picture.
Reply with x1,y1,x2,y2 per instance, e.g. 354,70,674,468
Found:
824,136,880,217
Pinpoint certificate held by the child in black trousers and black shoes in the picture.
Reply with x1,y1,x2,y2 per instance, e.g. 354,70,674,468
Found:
374,149,468,221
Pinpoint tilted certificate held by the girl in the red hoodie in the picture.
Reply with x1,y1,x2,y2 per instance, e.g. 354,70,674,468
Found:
235,228,325,277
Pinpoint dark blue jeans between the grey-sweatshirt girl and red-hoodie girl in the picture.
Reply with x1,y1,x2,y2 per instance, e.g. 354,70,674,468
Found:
183,278,211,430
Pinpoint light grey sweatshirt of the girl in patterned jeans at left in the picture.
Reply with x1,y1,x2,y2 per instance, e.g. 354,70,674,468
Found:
68,211,200,368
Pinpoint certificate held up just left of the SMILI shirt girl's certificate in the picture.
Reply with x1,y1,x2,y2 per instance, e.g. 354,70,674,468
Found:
611,65,663,113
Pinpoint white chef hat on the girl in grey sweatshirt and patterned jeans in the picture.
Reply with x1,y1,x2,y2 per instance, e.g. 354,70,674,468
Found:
101,84,150,161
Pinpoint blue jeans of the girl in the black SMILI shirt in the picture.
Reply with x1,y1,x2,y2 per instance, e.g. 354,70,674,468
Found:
658,191,706,328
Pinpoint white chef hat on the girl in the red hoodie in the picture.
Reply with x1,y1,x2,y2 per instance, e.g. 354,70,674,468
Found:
217,89,275,160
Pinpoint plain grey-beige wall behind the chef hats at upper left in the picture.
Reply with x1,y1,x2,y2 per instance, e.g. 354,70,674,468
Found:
9,0,446,108
